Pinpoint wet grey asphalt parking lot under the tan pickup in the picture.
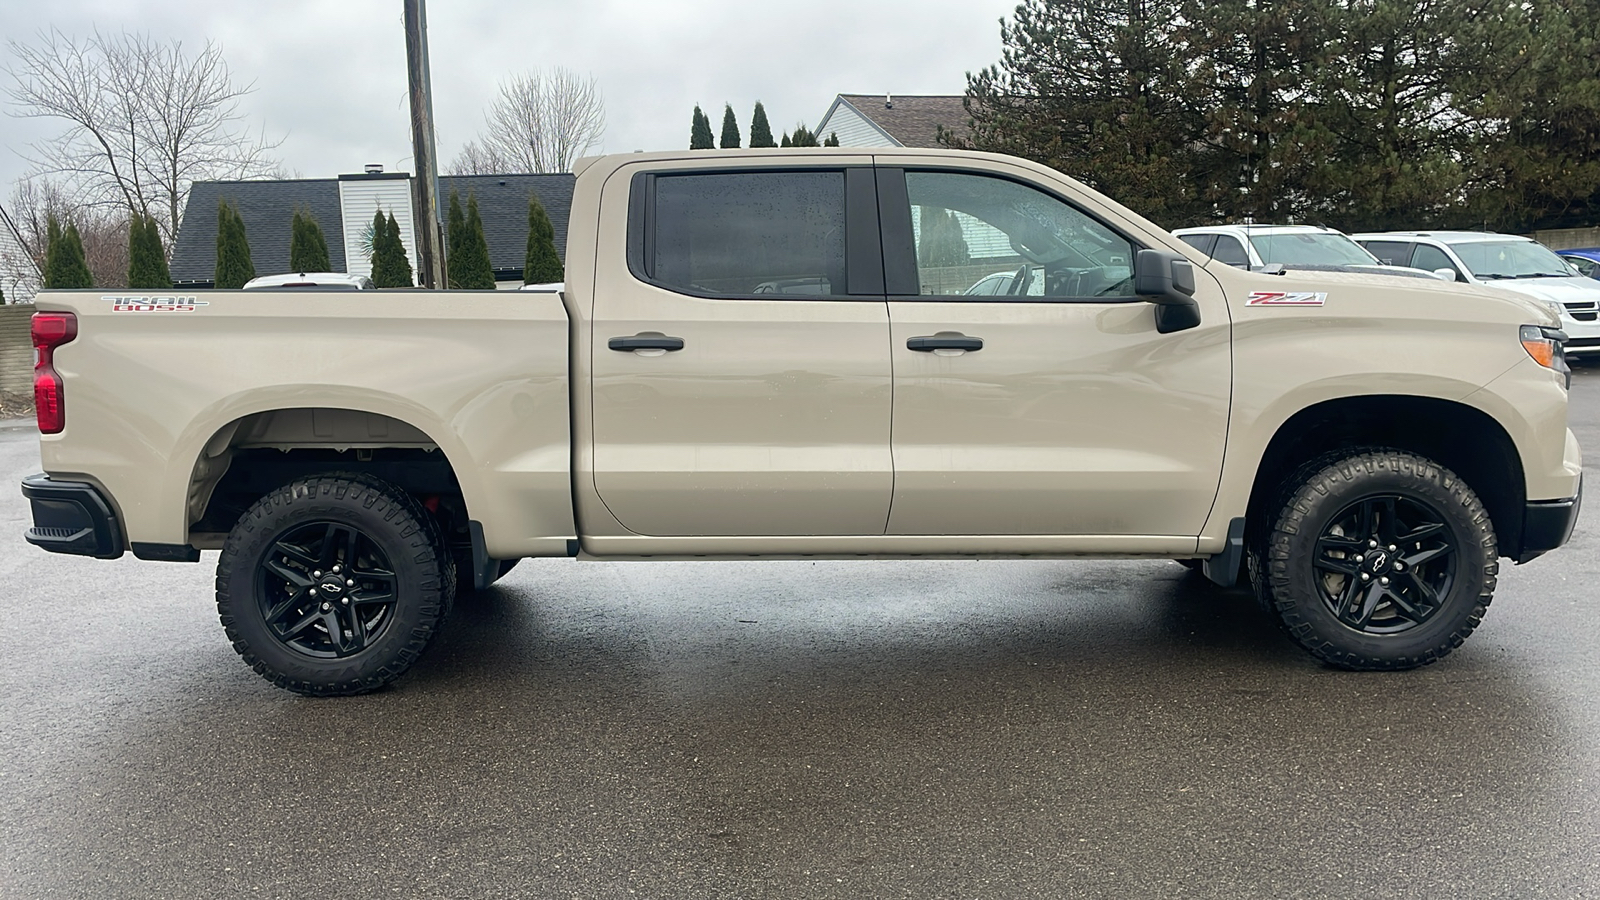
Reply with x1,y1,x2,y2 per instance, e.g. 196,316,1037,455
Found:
0,365,1600,898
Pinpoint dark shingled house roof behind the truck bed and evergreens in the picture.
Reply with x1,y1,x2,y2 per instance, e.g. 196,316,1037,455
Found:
171,173,576,280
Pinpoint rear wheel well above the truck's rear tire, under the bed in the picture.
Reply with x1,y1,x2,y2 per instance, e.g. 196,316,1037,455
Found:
189,407,470,549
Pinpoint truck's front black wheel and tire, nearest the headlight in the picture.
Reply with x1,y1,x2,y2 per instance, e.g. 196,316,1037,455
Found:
1262,450,1499,669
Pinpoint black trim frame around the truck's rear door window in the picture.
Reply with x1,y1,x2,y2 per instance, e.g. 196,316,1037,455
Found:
627,165,883,303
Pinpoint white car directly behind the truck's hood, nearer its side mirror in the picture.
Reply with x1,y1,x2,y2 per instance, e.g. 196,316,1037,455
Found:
1173,224,1440,279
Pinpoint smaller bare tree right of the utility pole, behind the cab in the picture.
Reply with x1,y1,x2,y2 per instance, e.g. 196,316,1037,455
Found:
450,67,605,175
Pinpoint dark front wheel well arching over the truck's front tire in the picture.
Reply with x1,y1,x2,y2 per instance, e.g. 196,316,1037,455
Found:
1245,396,1526,557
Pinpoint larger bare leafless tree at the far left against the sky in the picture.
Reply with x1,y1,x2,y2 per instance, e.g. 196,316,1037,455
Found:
6,29,278,245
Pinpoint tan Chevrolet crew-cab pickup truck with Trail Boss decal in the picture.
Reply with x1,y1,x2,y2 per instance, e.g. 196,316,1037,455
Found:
22,149,1582,693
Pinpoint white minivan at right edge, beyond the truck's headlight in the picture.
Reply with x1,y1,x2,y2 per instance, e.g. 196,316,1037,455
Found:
1354,231,1600,356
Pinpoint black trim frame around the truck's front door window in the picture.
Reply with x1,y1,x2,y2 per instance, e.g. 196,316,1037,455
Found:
875,165,1149,306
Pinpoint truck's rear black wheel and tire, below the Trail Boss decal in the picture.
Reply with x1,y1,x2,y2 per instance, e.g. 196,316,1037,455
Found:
216,476,454,697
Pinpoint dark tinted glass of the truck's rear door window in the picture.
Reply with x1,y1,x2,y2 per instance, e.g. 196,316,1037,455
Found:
645,171,845,299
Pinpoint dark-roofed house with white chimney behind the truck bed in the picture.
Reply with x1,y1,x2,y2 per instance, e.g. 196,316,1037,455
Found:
171,165,576,283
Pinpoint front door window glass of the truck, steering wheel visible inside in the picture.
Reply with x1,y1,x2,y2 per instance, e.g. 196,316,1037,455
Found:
906,171,1133,299
